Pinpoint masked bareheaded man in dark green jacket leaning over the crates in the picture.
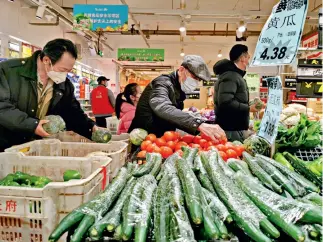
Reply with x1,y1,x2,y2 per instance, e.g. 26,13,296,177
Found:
0,39,97,151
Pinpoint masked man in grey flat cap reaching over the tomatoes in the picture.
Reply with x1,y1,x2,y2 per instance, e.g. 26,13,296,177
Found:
128,55,225,139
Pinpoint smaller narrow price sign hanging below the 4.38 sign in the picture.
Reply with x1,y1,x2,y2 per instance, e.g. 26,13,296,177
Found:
258,76,283,144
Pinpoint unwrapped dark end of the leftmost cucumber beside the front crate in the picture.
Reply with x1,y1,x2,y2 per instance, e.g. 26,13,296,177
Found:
48,210,85,242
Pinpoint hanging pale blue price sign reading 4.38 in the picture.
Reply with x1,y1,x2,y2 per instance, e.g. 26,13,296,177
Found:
251,0,308,66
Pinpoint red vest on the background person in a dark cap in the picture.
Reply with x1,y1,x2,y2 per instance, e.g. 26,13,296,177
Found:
91,85,114,115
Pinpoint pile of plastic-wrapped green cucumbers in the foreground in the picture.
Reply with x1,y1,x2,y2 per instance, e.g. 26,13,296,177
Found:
48,147,322,242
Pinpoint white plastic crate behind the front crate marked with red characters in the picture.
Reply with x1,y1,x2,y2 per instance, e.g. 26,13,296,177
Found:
5,139,128,179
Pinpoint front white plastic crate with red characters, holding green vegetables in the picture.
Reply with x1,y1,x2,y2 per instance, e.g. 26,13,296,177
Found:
0,152,111,242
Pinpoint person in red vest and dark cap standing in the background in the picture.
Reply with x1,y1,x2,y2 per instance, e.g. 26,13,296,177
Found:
91,76,115,128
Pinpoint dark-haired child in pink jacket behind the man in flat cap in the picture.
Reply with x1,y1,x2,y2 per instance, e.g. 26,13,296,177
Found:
115,83,141,134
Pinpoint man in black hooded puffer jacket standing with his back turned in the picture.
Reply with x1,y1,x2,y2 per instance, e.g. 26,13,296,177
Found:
213,44,256,141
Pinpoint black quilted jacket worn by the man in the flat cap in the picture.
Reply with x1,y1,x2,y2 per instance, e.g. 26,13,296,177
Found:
128,72,202,137
